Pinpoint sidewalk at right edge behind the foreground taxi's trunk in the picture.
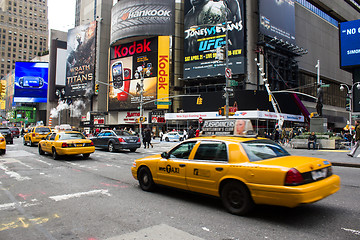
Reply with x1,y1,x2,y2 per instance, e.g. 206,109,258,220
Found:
285,147,360,168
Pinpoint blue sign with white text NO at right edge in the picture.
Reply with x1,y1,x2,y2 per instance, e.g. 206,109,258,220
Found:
340,20,360,68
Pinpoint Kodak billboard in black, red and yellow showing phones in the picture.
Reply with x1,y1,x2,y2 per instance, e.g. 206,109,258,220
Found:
108,36,170,111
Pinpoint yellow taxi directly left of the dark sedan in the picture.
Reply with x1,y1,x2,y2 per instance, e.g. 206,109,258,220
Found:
38,131,95,159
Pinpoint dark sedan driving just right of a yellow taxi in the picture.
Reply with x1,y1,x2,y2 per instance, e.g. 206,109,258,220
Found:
90,130,141,152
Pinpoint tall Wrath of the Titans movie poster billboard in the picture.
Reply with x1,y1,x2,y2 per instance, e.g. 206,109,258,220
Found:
65,21,96,97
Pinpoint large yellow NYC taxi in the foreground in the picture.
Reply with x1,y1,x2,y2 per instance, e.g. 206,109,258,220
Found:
131,136,340,215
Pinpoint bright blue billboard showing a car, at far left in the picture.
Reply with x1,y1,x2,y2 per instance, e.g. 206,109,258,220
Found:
14,62,49,102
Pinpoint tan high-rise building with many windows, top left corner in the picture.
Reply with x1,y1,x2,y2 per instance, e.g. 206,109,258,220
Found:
0,0,49,78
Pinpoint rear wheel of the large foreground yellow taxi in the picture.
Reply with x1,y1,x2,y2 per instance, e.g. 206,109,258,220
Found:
221,182,254,215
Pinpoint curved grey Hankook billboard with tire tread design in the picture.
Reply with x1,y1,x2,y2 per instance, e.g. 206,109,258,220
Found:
110,0,175,44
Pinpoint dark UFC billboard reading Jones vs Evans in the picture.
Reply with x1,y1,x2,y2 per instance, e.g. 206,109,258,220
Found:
184,0,245,78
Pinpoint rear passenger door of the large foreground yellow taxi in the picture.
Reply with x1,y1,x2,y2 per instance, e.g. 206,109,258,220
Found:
186,141,229,196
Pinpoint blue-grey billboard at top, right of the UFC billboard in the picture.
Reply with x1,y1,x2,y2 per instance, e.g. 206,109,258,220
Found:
259,0,295,44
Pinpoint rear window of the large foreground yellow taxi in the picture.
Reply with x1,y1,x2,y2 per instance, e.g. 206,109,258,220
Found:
241,140,290,162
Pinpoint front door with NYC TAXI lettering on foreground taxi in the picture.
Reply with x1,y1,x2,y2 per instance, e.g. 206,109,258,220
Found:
157,141,196,190
